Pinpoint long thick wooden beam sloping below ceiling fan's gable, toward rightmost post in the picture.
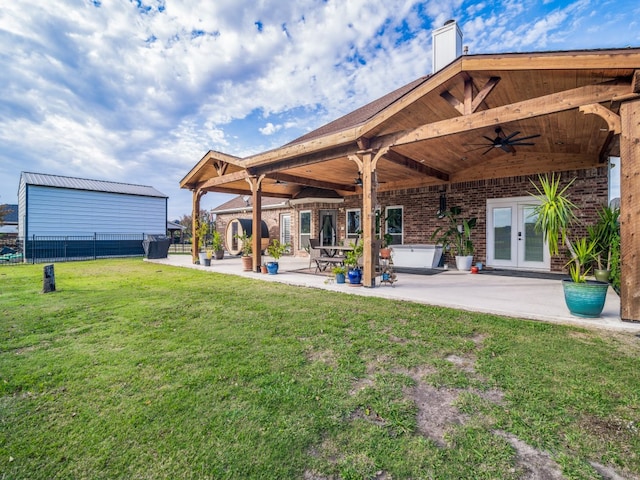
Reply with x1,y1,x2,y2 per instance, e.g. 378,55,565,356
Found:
390,82,640,148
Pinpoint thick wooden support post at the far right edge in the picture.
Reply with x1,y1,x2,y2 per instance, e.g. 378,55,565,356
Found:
620,100,640,322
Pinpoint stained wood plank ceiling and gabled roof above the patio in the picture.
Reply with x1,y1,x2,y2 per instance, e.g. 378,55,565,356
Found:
181,49,640,197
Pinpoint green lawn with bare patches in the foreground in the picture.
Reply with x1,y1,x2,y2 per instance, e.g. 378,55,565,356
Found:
0,259,640,479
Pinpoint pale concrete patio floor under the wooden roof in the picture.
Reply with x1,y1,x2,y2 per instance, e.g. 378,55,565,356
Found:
146,255,640,334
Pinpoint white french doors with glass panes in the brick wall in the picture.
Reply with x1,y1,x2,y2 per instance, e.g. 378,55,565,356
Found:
487,197,550,271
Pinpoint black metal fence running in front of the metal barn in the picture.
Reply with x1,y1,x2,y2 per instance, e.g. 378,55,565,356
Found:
0,233,151,265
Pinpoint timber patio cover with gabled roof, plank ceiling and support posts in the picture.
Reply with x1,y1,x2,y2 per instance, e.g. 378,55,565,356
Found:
181,48,640,321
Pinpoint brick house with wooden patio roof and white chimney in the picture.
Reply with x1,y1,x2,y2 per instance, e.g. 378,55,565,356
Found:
181,23,640,321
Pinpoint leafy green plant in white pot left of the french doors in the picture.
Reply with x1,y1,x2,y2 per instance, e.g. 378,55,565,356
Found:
431,207,478,272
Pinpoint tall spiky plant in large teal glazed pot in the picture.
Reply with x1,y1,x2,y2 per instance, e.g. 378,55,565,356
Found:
531,174,609,317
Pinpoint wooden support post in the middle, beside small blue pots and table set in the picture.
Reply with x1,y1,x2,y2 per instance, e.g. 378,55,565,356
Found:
362,150,377,287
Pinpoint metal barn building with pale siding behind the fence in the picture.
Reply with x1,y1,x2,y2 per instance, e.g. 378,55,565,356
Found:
18,172,168,260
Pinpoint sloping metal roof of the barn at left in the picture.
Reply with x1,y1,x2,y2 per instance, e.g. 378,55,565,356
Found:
21,172,168,198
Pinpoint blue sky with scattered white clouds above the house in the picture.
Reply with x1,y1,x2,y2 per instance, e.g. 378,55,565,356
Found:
0,0,640,220
